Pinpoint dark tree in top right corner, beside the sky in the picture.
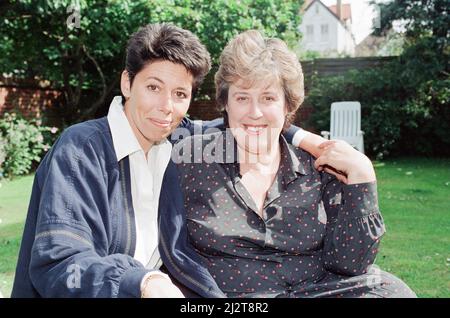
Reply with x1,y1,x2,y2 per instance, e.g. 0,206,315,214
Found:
375,0,450,105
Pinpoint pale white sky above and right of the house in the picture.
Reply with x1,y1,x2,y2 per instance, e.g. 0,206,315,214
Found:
322,0,385,44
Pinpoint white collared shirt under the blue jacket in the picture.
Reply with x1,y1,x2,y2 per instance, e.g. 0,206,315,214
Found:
108,96,172,269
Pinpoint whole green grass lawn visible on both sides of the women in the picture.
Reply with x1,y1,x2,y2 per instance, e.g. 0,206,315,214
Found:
0,158,450,297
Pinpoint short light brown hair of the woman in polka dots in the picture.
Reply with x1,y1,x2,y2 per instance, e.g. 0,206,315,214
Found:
215,30,305,128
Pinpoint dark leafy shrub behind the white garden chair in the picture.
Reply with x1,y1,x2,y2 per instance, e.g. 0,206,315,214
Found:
305,57,450,159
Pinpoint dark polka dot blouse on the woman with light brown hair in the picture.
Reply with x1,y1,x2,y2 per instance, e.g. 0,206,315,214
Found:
177,132,385,297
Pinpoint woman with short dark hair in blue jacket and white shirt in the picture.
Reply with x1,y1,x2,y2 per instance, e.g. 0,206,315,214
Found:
12,23,211,297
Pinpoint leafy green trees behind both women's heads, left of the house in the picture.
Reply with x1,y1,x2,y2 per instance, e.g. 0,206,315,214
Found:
0,0,303,124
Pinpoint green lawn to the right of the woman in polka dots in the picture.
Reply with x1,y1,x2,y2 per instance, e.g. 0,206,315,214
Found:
375,158,450,297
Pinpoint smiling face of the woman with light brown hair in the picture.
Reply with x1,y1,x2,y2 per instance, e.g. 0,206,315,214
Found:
225,79,287,154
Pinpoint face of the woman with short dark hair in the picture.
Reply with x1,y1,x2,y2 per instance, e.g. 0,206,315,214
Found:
121,61,193,151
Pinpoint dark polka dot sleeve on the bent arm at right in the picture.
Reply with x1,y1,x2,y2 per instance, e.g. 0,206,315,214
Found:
322,173,385,276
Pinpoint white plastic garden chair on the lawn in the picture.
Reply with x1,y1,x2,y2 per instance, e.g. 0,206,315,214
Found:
321,102,364,153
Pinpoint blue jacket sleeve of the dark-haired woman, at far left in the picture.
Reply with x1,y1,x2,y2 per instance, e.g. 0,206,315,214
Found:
29,130,148,297
